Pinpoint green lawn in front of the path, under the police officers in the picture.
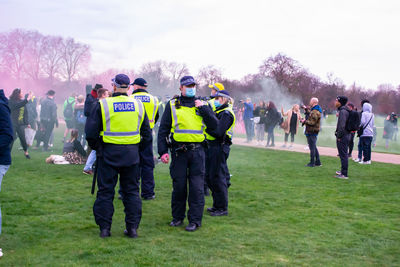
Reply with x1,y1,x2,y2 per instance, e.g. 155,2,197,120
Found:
0,130,400,266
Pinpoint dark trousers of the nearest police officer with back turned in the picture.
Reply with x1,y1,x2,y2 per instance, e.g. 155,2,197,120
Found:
93,157,142,229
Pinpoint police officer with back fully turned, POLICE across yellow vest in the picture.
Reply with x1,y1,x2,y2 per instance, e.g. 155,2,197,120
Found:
85,74,152,238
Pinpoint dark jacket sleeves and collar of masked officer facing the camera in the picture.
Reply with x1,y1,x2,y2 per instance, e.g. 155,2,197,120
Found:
157,95,218,156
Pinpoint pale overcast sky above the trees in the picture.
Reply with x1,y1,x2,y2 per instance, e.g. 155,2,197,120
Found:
0,0,400,88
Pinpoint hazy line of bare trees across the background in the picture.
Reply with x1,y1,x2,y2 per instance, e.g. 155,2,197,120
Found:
0,29,400,114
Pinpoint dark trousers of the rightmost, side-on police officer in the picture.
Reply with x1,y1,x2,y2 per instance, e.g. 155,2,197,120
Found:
206,143,230,213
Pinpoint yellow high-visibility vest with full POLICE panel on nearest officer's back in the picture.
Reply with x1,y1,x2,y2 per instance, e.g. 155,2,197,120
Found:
100,95,145,145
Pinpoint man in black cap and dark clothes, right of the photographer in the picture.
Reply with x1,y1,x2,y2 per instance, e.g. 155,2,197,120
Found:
335,96,350,179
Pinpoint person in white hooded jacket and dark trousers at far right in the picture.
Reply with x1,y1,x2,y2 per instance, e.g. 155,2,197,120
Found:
358,103,374,164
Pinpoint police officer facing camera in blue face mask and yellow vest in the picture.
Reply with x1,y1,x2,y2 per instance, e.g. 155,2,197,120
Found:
158,76,217,231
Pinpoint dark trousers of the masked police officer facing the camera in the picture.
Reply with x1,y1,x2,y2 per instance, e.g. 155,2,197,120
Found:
170,146,205,225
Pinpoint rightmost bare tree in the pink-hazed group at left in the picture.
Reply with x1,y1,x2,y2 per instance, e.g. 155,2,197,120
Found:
61,38,90,82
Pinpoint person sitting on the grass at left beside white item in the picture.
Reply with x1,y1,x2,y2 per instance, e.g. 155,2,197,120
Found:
46,129,86,164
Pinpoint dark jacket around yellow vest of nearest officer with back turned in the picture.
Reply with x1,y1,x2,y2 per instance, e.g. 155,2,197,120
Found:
85,93,153,167
